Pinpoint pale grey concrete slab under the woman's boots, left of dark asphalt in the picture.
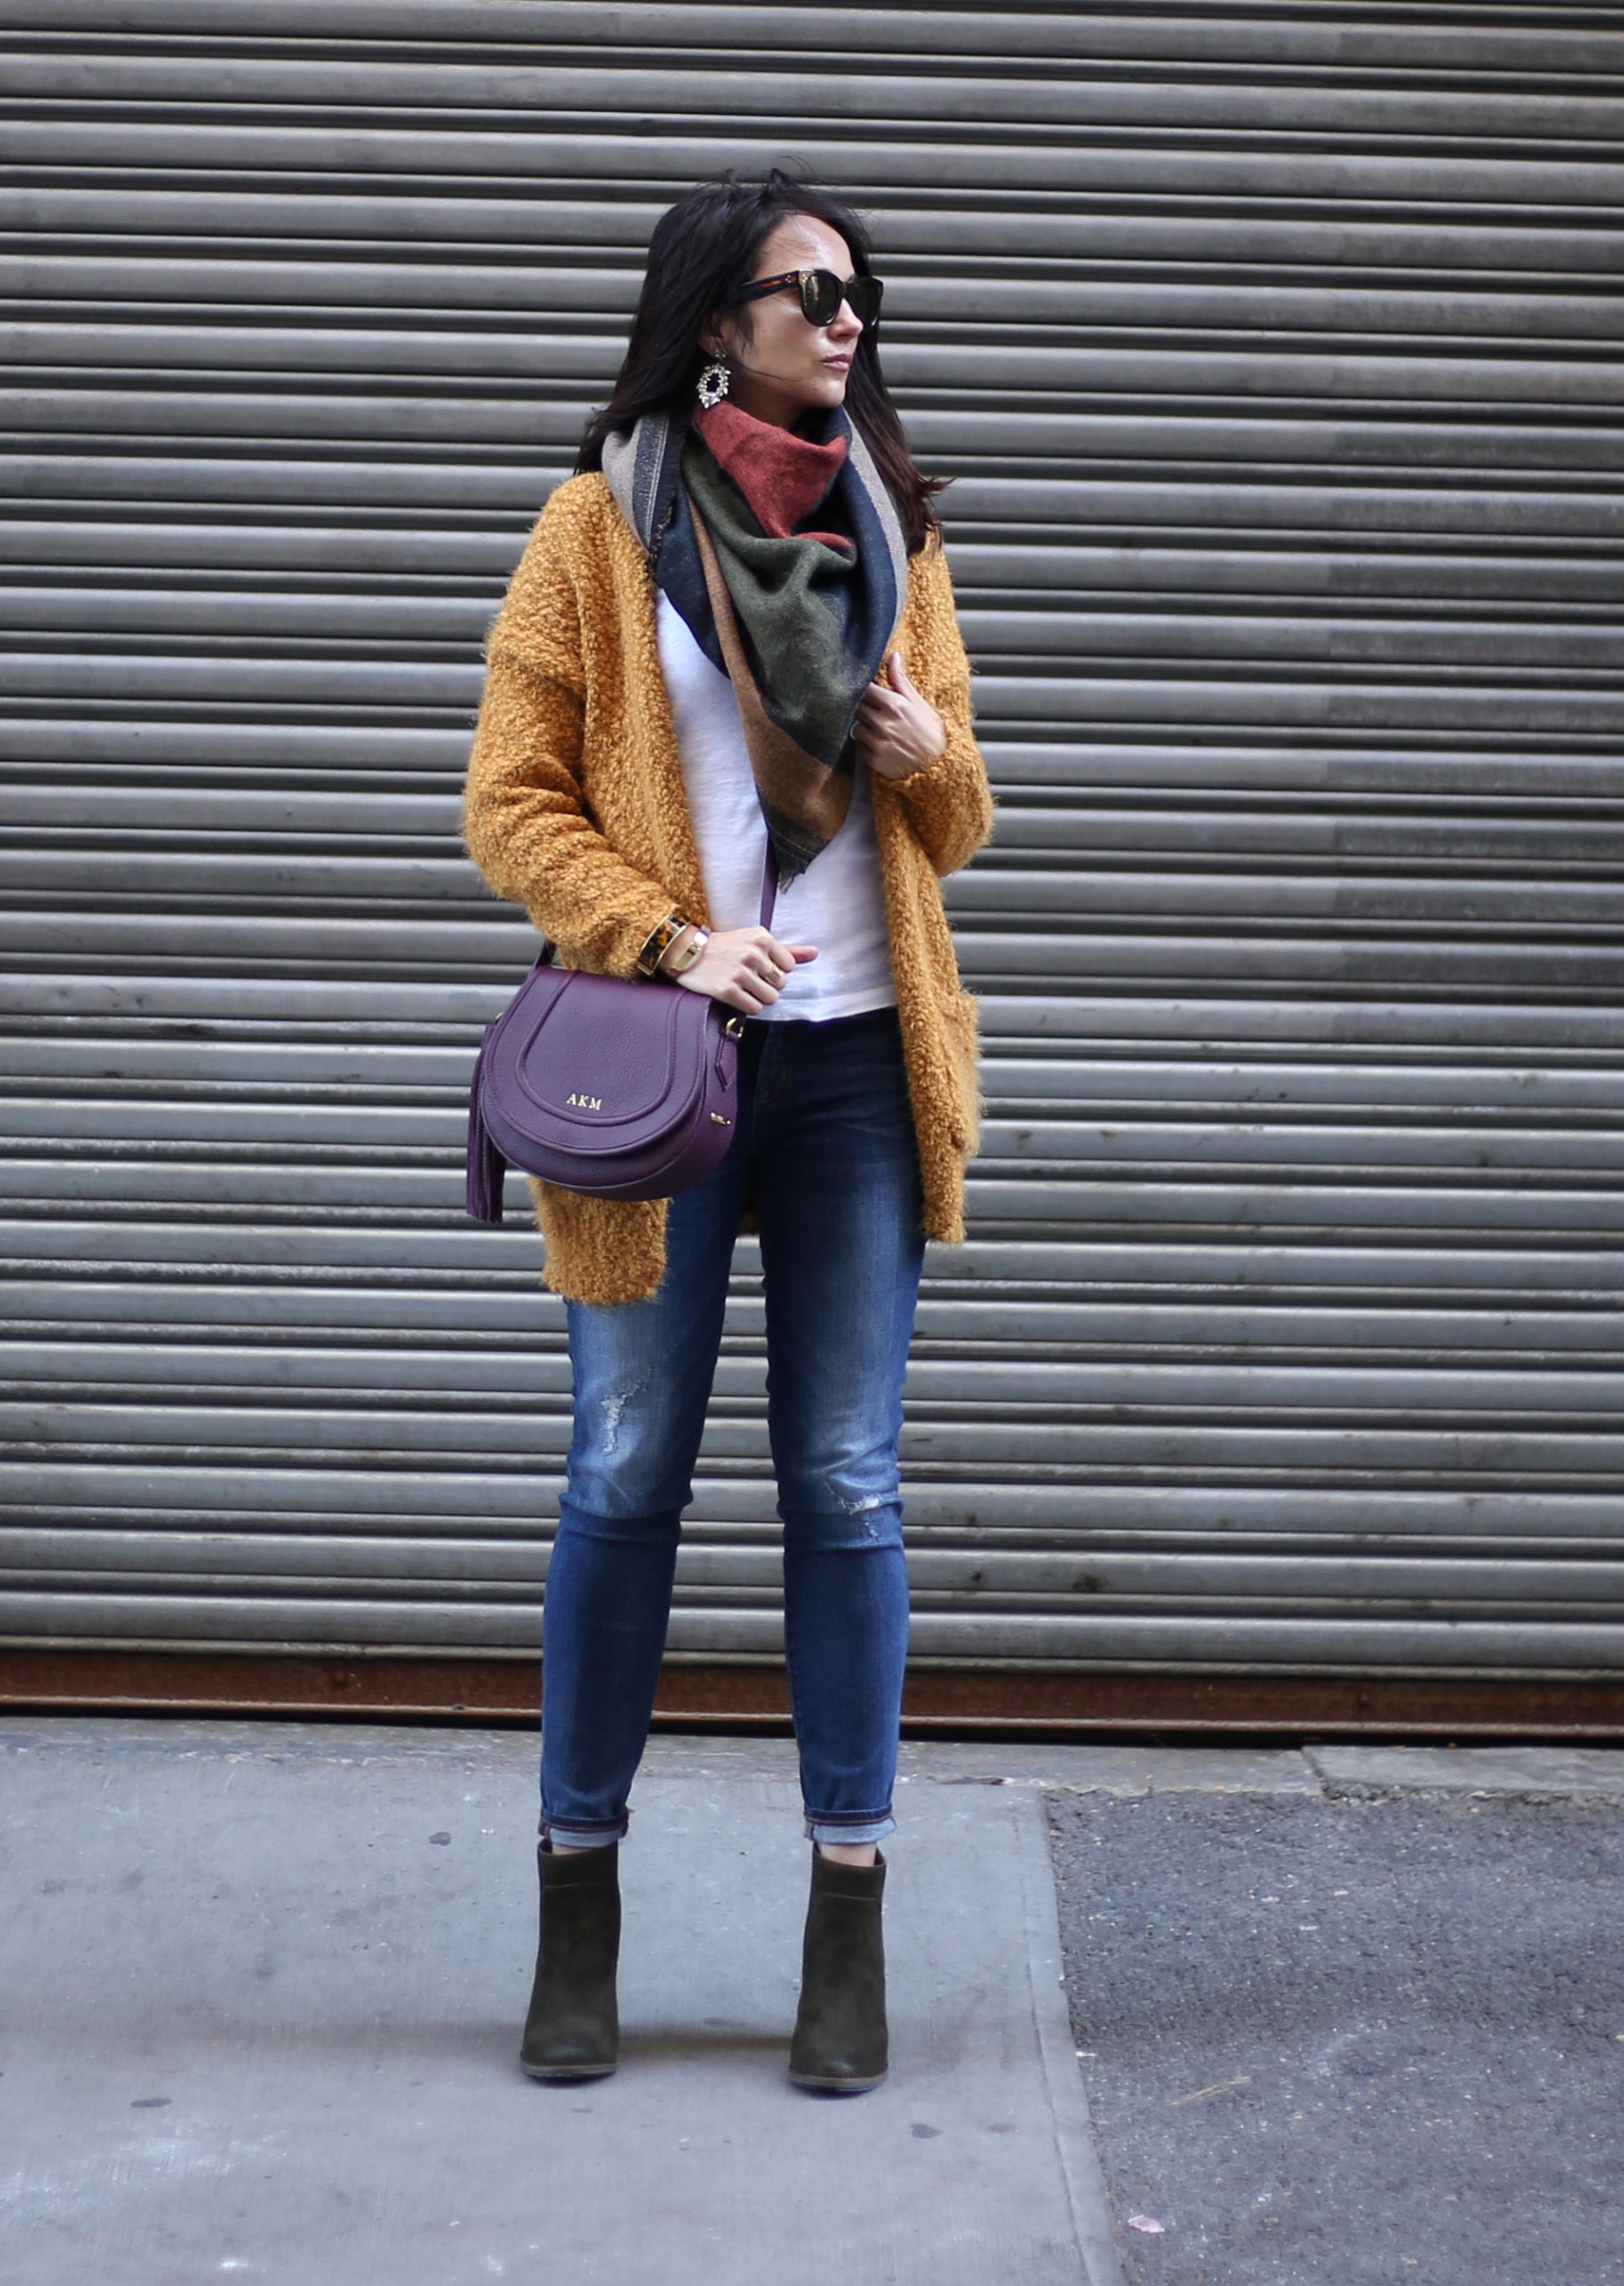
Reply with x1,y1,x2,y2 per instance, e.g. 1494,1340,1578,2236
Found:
0,1717,1121,2286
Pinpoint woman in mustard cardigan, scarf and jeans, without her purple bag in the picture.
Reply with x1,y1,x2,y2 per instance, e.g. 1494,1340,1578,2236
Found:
466,171,991,2091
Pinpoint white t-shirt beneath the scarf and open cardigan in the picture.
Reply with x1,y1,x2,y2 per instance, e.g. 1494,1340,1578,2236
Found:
658,595,897,1024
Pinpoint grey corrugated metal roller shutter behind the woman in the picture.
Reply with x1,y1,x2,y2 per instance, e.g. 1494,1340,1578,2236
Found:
0,0,1624,1675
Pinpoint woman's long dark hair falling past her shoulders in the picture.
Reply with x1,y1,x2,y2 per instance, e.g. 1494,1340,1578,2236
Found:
576,167,944,554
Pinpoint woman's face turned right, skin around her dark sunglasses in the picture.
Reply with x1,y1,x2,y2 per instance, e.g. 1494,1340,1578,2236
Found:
701,215,863,428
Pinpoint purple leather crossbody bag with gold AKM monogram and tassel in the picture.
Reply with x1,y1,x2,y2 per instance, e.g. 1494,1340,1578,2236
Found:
468,864,777,1223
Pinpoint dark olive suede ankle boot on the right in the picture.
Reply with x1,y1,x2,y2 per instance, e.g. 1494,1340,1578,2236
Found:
790,1842,888,2097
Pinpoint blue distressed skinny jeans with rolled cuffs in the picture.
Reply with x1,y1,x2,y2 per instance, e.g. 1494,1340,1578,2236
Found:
541,1008,923,1847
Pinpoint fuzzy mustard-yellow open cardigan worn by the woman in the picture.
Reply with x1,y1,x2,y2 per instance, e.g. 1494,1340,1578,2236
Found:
463,475,991,1303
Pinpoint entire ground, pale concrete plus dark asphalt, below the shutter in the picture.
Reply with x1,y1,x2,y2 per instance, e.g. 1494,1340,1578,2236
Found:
12,1717,1624,2286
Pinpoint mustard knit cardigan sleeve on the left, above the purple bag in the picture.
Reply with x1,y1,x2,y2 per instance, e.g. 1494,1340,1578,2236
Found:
463,494,671,976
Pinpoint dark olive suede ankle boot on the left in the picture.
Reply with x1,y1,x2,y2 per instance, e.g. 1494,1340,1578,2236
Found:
519,1842,621,2081
